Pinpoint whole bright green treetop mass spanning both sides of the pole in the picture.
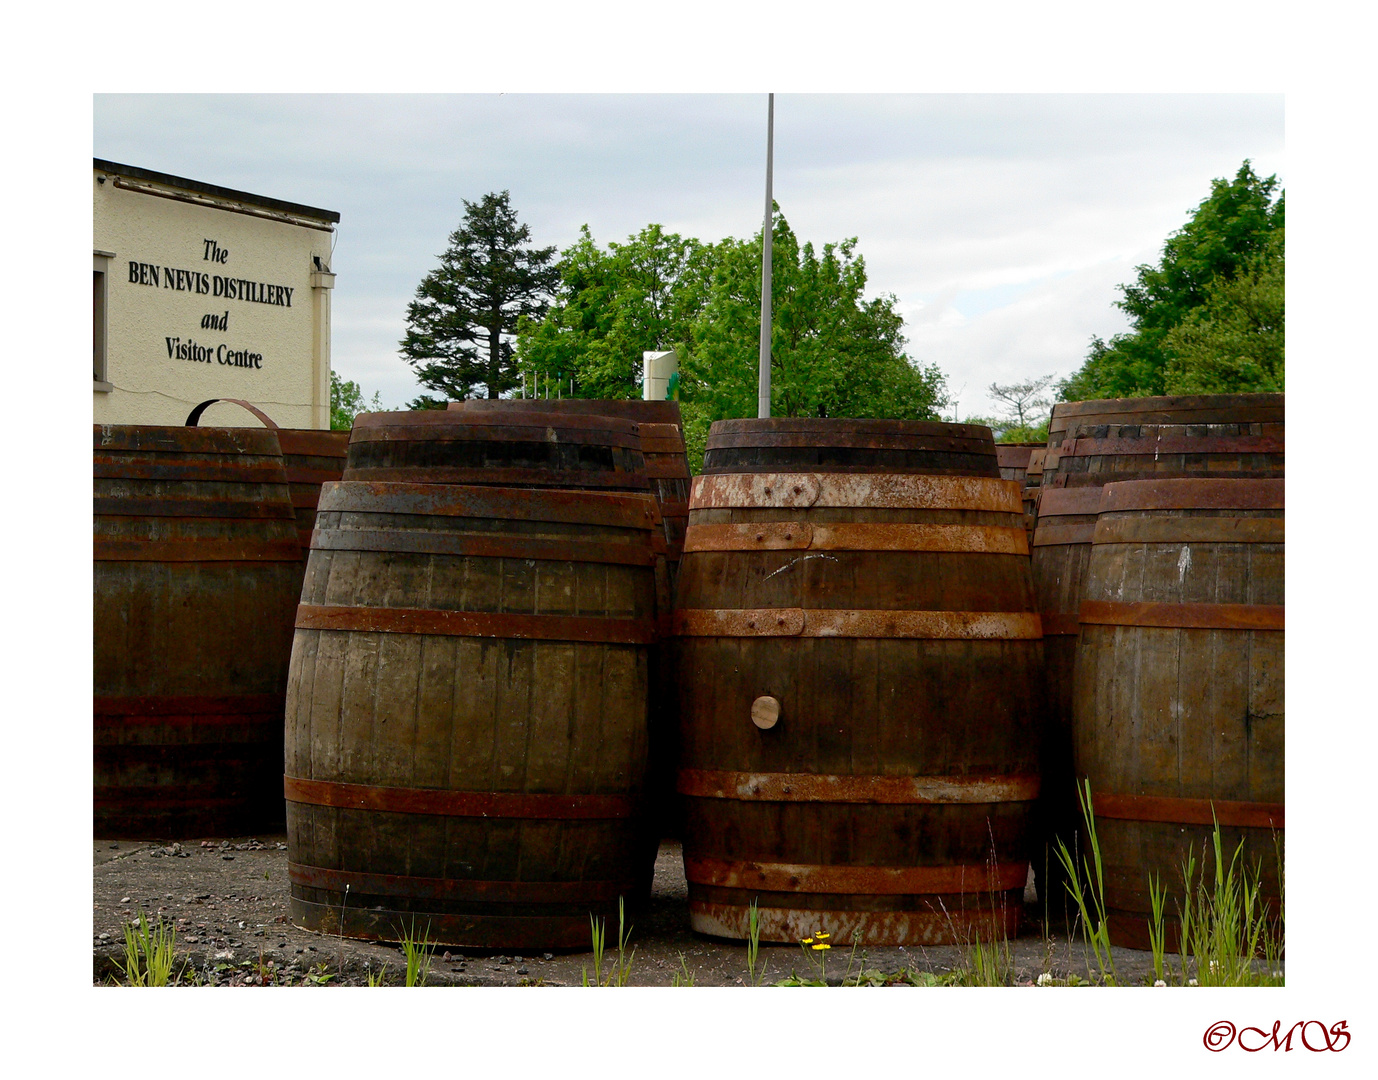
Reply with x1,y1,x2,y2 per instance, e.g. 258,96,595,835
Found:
518,211,947,463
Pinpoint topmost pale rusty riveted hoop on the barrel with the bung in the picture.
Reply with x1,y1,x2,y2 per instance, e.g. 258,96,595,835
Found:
689,473,1024,514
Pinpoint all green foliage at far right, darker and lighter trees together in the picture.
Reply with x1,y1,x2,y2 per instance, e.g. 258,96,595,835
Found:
1058,161,1284,401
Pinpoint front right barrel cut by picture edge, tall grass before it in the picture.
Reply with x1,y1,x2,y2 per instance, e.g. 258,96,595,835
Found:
1073,479,1284,949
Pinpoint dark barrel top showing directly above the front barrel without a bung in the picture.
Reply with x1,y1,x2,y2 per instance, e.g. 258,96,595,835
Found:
345,409,650,492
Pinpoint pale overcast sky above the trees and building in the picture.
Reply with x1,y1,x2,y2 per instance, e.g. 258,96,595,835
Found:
94,94,1286,416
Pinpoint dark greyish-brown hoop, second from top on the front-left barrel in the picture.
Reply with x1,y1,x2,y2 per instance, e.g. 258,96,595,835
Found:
311,529,656,566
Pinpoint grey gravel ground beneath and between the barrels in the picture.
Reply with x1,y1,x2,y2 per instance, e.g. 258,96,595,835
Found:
92,835,1152,986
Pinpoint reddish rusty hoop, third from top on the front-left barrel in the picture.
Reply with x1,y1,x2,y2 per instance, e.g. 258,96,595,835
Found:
296,603,656,645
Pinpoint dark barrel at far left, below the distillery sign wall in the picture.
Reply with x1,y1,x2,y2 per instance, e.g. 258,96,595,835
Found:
94,424,302,839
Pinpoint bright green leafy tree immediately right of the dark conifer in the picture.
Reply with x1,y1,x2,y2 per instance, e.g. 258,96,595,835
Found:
517,225,712,398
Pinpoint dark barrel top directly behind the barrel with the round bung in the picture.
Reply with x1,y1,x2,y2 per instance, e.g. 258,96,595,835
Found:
703,417,1000,477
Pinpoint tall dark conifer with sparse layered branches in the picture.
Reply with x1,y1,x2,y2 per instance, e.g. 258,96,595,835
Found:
401,191,558,408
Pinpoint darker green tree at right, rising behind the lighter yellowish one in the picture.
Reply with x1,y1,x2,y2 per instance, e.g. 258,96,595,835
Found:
1058,161,1284,401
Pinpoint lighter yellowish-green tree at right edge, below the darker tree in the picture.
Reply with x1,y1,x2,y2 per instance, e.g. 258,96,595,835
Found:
1166,229,1286,394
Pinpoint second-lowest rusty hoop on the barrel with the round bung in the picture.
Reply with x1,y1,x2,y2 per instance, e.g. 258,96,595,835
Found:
683,853,1028,897
